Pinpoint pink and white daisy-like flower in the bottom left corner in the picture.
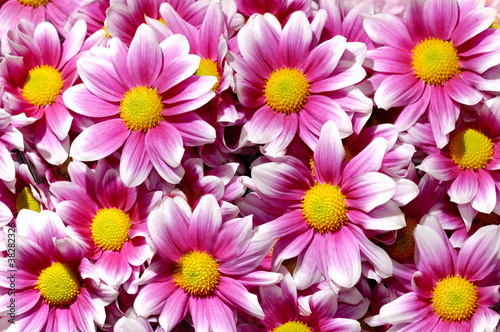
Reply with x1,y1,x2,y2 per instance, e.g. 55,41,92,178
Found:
0,210,117,332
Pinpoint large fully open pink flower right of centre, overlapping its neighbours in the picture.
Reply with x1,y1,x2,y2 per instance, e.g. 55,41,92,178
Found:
252,121,405,289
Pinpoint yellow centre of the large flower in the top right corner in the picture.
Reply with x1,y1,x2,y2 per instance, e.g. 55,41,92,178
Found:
411,38,462,85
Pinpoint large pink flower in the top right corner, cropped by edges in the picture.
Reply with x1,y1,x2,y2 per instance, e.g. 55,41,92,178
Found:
364,0,500,147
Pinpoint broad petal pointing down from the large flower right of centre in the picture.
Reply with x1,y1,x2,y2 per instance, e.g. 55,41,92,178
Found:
313,227,361,288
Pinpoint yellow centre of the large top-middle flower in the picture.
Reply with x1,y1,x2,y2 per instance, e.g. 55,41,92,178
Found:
264,68,310,114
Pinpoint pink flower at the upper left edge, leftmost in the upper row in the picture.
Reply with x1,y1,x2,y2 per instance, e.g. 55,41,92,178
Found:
0,20,86,165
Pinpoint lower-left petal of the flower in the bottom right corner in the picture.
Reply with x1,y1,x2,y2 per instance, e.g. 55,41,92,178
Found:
380,293,432,324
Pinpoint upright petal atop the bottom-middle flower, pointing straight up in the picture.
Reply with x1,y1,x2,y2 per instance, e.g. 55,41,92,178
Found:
189,195,222,253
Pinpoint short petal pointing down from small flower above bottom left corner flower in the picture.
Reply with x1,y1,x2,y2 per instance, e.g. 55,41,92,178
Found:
95,250,132,287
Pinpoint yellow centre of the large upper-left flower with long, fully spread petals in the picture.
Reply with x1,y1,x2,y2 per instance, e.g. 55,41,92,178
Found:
120,86,163,133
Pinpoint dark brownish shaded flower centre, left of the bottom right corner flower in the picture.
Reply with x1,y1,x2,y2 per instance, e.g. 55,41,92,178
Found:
384,217,418,264
